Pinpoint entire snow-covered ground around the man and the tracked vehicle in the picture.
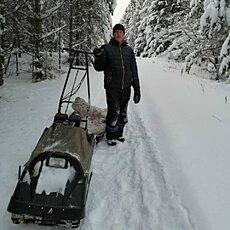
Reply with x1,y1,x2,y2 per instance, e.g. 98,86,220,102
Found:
0,56,230,230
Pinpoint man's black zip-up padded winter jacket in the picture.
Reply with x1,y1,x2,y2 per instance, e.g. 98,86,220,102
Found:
94,38,140,89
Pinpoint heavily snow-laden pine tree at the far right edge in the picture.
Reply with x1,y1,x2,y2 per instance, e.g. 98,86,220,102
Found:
200,0,230,80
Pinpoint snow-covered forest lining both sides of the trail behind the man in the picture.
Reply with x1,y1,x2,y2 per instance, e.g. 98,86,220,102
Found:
0,0,230,85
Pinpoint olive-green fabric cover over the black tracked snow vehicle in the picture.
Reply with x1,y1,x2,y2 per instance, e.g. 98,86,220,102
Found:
29,123,93,173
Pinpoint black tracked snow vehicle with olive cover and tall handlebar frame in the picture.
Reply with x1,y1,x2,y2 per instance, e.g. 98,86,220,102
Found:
8,50,99,227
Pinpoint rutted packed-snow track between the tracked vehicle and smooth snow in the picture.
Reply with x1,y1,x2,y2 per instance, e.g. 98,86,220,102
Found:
81,104,194,230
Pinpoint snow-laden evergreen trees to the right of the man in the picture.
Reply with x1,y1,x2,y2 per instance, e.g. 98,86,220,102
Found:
122,0,230,80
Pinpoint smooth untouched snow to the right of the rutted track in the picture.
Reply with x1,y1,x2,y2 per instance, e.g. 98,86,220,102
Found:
137,58,230,229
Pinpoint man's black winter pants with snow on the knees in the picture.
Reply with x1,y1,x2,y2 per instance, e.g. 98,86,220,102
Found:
106,87,131,140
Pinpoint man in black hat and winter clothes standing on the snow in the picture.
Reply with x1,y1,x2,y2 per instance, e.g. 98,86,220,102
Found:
93,24,141,146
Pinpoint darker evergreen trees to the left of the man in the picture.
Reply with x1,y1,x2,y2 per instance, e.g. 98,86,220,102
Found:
0,0,116,83
